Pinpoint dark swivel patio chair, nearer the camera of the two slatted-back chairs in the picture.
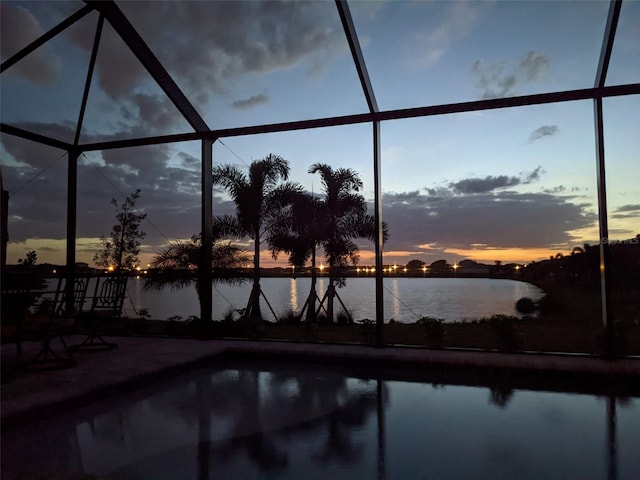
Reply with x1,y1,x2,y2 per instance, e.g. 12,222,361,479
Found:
21,276,89,370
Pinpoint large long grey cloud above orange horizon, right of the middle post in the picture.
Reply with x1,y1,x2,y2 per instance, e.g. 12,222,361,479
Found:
383,191,597,255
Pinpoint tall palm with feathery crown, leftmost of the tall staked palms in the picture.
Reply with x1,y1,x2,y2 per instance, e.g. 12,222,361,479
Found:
213,154,299,320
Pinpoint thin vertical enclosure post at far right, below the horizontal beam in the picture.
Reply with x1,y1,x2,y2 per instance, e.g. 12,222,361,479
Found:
593,97,614,358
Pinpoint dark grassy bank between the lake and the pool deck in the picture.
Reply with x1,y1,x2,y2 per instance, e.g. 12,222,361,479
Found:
81,316,640,355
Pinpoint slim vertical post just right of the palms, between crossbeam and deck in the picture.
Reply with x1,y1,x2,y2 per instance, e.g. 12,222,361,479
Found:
373,120,384,348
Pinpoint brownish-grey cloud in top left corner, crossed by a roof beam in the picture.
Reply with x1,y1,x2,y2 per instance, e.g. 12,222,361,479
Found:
0,3,61,84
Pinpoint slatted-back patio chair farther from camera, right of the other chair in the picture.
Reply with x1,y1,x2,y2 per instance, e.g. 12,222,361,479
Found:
71,275,129,351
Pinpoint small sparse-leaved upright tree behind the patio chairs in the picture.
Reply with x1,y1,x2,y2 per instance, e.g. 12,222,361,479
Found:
93,189,147,271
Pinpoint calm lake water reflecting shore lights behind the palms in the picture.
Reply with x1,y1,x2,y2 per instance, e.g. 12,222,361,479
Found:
124,277,543,322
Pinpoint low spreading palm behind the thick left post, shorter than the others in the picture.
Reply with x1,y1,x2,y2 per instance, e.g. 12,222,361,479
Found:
144,235,248,320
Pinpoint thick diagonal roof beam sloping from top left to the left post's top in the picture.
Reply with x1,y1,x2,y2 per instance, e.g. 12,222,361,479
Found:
85,0,209,132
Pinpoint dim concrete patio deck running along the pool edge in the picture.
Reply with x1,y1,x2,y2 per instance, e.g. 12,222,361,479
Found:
1,337,640,429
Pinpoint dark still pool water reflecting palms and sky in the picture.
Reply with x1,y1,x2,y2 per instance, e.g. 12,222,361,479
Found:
2,362,640,480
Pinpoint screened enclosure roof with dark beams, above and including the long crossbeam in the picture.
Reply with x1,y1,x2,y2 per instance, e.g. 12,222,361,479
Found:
1,0,640,151
